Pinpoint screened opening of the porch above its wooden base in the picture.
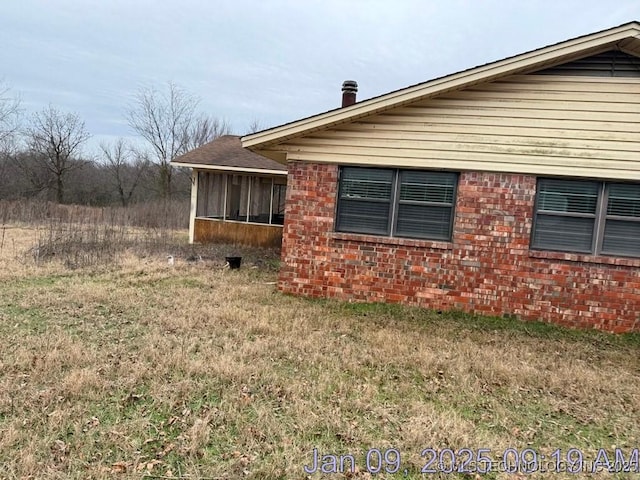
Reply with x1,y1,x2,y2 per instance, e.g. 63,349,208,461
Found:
196,171,287,225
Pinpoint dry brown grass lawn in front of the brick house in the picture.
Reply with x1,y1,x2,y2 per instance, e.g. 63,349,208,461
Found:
0,225,640,479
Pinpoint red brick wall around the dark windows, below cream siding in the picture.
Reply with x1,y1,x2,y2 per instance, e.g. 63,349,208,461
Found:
279,162,640,332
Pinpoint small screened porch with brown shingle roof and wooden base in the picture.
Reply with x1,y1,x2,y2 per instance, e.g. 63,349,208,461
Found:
171,135,287,247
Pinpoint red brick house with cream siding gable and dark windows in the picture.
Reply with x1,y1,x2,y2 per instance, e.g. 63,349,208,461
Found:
242,22,640,332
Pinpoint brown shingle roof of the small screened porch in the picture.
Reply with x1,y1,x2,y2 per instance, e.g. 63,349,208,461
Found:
171,135,287,175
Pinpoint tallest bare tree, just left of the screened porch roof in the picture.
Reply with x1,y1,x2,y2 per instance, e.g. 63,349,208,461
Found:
127,82,229,198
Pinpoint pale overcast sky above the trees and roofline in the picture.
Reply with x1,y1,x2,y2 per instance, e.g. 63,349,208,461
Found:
0,0,640,153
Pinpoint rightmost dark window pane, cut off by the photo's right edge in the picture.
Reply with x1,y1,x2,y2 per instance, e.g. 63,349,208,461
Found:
602,183,640,256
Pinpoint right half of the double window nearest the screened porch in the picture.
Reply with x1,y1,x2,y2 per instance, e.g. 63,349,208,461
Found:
395,170,457,240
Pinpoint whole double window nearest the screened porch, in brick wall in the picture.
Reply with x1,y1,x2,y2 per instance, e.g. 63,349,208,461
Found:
336,167,458,241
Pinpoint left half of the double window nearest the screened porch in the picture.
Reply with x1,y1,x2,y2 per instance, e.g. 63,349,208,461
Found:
336,167,394,235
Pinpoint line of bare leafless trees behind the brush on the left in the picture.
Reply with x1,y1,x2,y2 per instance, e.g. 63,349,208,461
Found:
0,82,252,206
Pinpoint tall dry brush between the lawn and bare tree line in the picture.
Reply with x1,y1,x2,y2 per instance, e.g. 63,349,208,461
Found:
0,200,195,268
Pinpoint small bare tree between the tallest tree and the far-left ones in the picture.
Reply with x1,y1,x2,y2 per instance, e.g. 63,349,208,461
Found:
100,138,149,207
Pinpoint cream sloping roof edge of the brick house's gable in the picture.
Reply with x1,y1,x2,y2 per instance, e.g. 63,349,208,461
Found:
241,21,640,161
